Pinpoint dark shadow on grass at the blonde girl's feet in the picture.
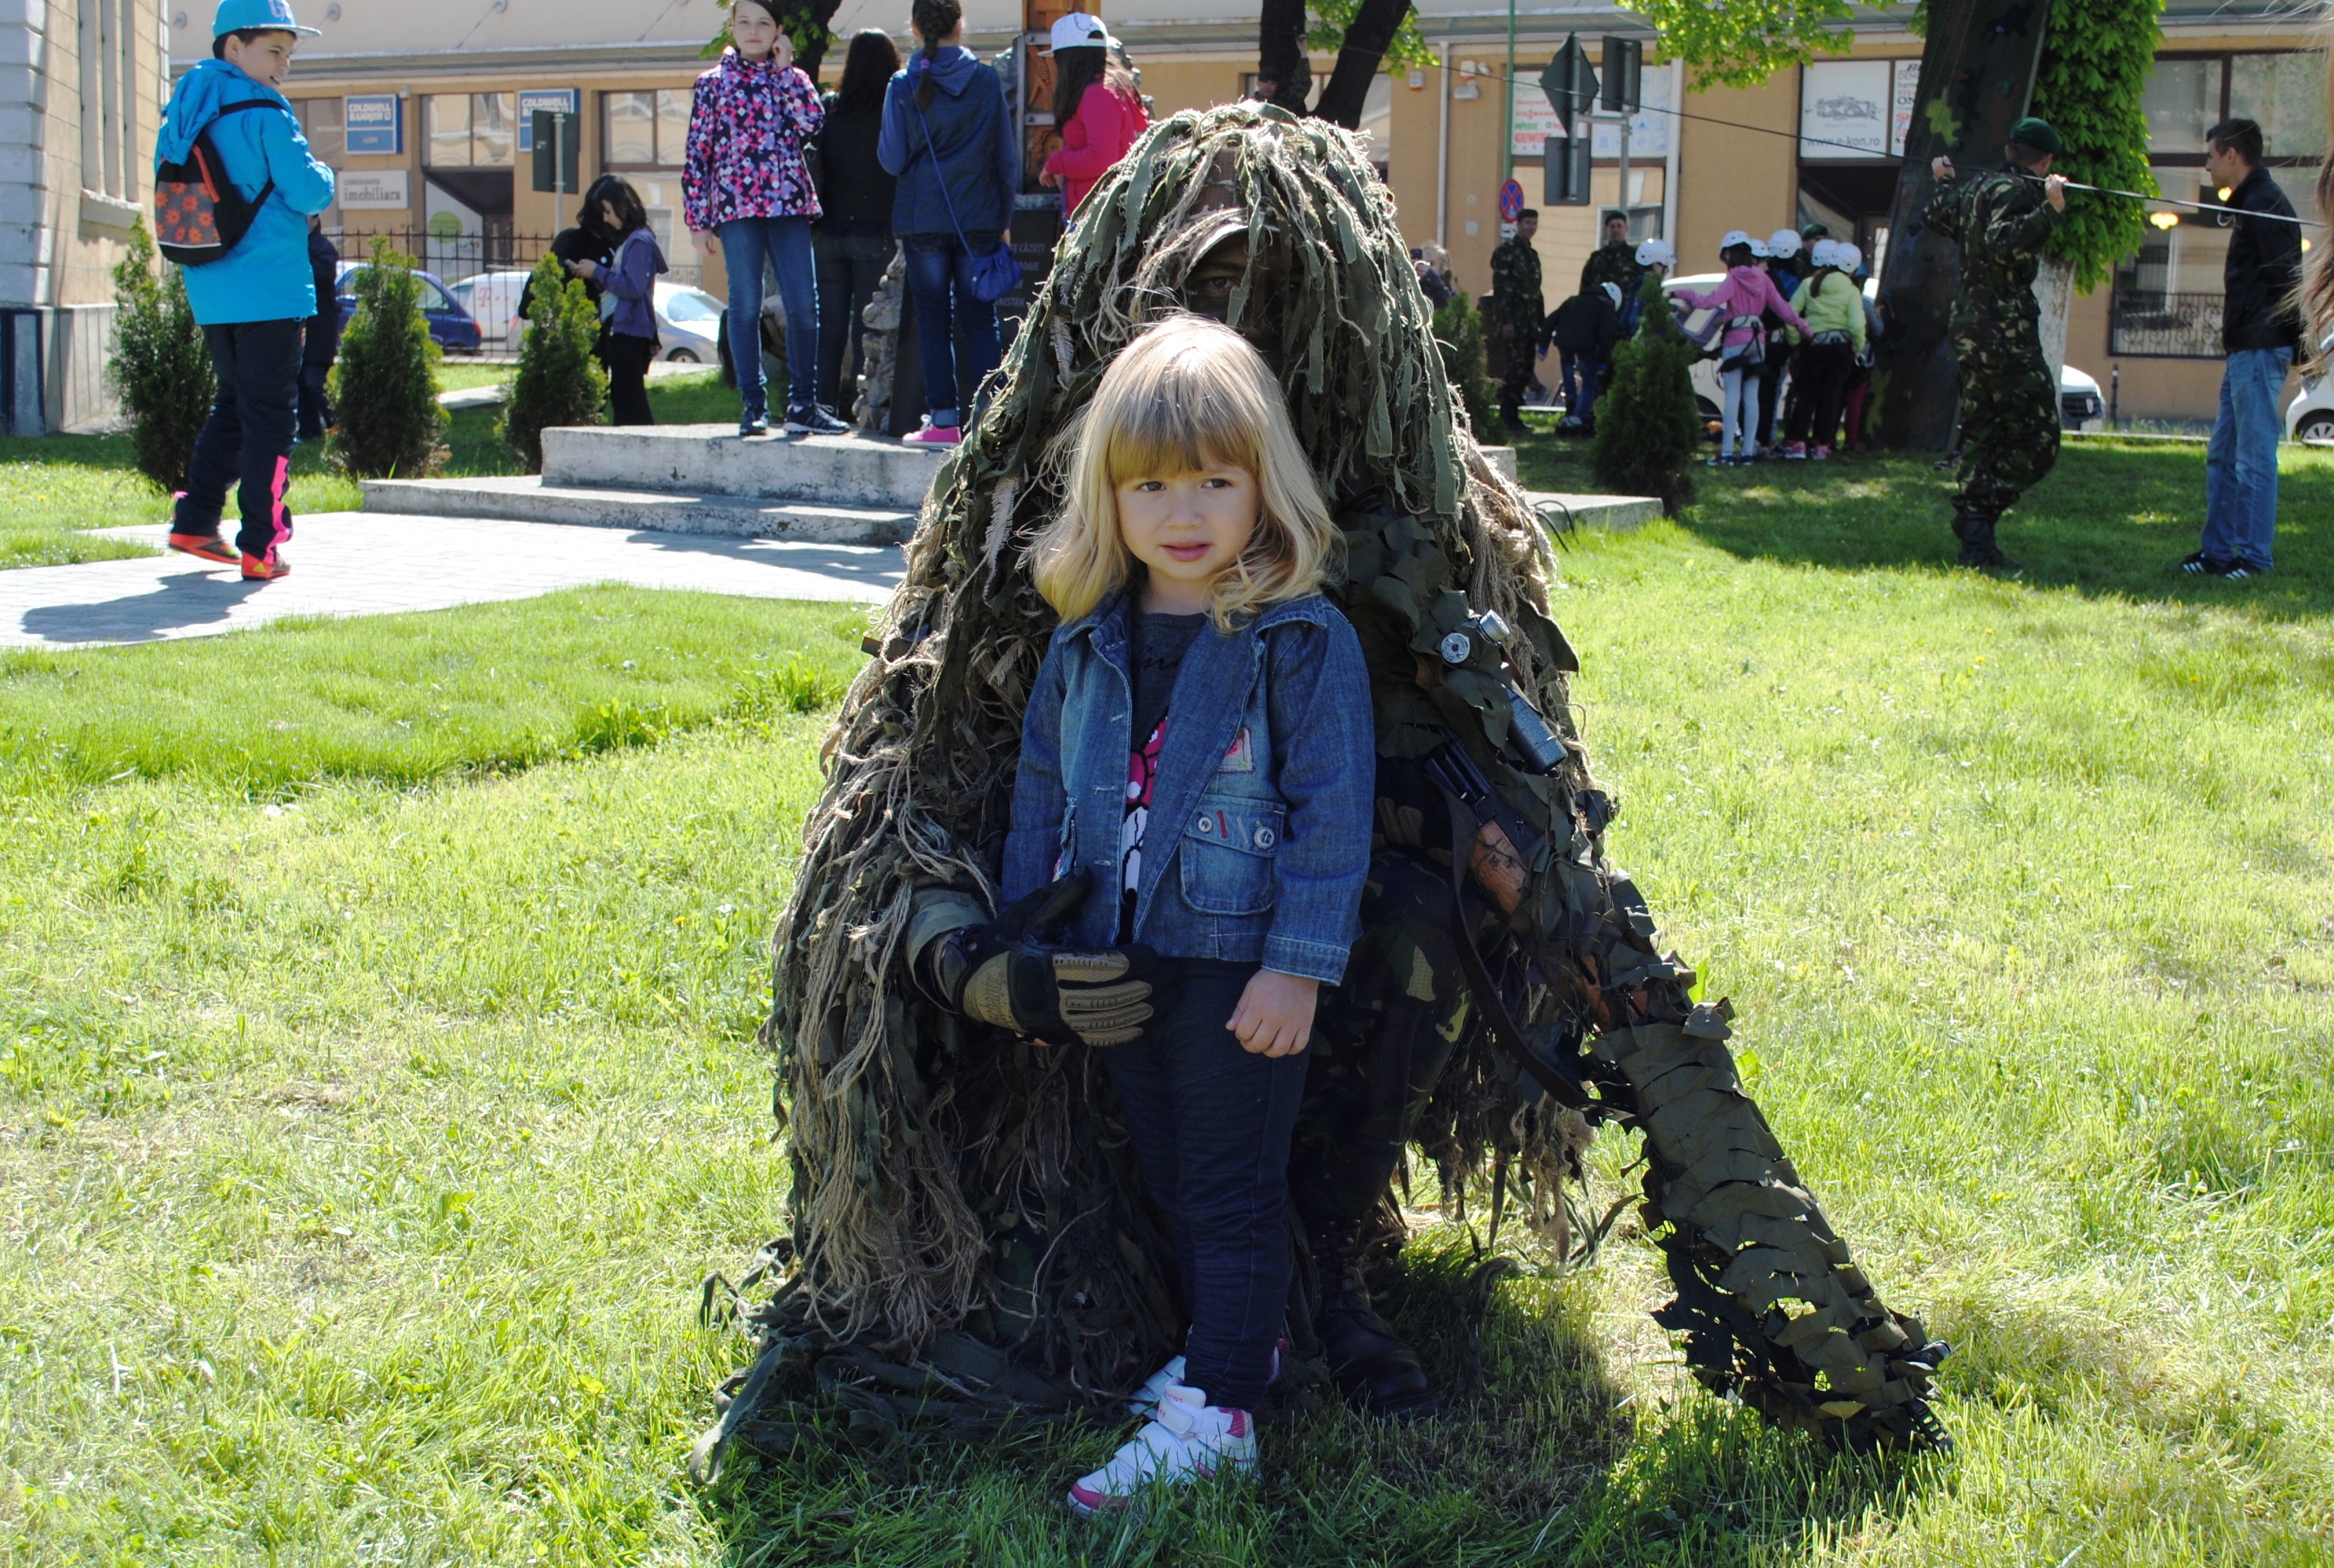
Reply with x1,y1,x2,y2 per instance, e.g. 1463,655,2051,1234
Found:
705,1248,1937,1568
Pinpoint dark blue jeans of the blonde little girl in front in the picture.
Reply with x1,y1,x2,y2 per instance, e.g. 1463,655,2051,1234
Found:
1102,959,1312,1410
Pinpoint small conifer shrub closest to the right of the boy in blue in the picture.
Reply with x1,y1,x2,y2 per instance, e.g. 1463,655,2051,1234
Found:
331,236,446,479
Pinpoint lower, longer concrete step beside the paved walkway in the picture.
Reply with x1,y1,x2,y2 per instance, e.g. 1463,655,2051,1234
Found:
362,471,915,543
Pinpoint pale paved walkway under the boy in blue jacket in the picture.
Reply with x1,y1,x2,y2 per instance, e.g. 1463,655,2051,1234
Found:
0,511,901,649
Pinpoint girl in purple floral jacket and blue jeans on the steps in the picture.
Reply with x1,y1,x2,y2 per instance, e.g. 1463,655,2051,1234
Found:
682,0,847,437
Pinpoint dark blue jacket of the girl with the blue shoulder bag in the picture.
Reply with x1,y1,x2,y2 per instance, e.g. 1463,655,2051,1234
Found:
875,49,1020,250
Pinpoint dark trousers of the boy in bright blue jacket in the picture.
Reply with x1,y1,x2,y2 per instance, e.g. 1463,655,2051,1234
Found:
170,320,306,558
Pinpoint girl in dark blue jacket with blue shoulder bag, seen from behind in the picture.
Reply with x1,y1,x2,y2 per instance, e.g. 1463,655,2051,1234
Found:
875,0,1020,446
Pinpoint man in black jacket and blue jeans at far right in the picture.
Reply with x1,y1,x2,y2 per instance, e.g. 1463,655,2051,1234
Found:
2180,119,2302,581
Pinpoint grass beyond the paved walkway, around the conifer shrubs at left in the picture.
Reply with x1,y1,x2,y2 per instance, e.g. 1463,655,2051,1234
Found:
0,362,738,569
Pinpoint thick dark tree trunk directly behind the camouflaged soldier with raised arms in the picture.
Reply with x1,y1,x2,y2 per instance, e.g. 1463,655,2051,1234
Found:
1872,0,2050,450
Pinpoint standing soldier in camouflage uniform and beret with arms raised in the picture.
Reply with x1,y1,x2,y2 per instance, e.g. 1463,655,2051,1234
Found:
1924,119,2065,572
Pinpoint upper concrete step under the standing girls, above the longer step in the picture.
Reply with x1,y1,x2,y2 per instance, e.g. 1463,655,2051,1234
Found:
544,425,946,513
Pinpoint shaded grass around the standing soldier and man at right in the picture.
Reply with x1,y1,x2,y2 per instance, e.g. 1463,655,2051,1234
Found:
1524,437,2334,620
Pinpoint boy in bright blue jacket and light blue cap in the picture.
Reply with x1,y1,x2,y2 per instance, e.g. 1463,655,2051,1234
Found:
154,0,336,581
